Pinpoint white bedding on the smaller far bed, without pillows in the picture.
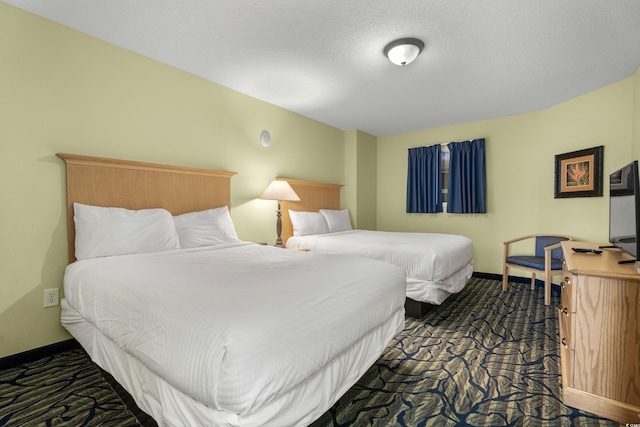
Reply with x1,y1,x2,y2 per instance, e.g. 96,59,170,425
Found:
287,230,473,304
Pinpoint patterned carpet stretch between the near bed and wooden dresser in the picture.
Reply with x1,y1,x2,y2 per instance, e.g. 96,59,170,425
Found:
313,278,618,427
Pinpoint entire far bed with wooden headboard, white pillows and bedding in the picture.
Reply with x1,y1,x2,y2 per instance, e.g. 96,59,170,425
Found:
280,178,473,318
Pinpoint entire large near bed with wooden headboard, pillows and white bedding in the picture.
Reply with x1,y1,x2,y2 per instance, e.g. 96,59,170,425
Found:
59,155,405,426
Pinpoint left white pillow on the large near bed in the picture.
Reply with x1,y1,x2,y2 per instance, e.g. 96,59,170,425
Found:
73,203,180,260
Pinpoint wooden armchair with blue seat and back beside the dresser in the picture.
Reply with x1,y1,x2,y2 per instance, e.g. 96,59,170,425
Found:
502,234,573,305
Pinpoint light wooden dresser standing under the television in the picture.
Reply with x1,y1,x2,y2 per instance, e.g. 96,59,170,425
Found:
558,241,640,425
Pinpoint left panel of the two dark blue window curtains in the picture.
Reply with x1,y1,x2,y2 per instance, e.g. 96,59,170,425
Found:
407,144,442,213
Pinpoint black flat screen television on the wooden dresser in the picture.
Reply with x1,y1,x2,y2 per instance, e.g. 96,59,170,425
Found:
609,160,640,263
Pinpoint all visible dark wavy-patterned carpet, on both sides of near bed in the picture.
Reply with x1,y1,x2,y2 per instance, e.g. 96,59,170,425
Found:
0,278,618,427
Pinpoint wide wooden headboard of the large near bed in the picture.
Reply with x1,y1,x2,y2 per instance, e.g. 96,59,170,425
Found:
56,153,235,262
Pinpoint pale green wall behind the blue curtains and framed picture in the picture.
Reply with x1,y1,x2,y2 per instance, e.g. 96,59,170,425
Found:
377,73,640,275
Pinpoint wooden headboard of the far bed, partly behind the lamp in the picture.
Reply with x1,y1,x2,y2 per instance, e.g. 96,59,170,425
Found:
278,178,342,245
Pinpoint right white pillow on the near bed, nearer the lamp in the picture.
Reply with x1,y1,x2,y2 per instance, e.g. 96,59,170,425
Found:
173,206,240,249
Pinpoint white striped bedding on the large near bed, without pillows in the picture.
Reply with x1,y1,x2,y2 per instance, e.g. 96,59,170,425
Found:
62,243,405,425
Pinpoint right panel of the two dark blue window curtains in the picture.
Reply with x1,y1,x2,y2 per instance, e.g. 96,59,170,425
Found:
447,138,487,213
